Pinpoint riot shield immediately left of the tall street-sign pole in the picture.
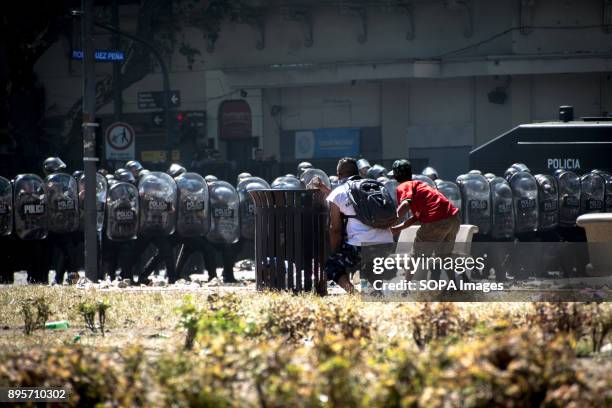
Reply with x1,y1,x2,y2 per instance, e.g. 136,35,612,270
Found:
45,173,79,234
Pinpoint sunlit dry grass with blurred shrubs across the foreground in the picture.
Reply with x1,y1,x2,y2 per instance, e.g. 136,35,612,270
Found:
0,286,612,407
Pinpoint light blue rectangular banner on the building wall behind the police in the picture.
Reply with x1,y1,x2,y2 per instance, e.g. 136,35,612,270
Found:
295,128,361,159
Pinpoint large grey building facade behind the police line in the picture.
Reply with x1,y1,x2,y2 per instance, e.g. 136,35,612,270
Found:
37,0,612,178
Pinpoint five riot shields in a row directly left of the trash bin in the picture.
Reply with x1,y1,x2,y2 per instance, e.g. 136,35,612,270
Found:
106,172,270,244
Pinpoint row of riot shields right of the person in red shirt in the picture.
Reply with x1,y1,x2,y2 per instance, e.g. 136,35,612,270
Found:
448,171,612,240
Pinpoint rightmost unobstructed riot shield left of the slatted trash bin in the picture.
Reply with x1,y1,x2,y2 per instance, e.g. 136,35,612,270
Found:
206,179,241,244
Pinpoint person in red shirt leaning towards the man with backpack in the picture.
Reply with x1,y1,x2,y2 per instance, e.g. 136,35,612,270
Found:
391,160,461,257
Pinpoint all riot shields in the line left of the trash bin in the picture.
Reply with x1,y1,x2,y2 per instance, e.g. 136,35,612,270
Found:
0,172,270,243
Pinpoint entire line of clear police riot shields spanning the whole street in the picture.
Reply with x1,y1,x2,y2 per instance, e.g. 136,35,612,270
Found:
0,168,612,243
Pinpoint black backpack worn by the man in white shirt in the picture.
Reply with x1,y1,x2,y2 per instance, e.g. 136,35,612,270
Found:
346,177,397,229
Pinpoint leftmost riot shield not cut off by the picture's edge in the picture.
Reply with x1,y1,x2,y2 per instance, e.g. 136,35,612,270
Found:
13,174,48,239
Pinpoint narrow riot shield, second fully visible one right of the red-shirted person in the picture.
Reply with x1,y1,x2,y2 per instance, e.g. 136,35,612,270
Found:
489,177,514,240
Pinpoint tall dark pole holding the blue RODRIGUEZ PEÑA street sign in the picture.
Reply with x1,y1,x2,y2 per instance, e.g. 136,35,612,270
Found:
81,0,99,282
